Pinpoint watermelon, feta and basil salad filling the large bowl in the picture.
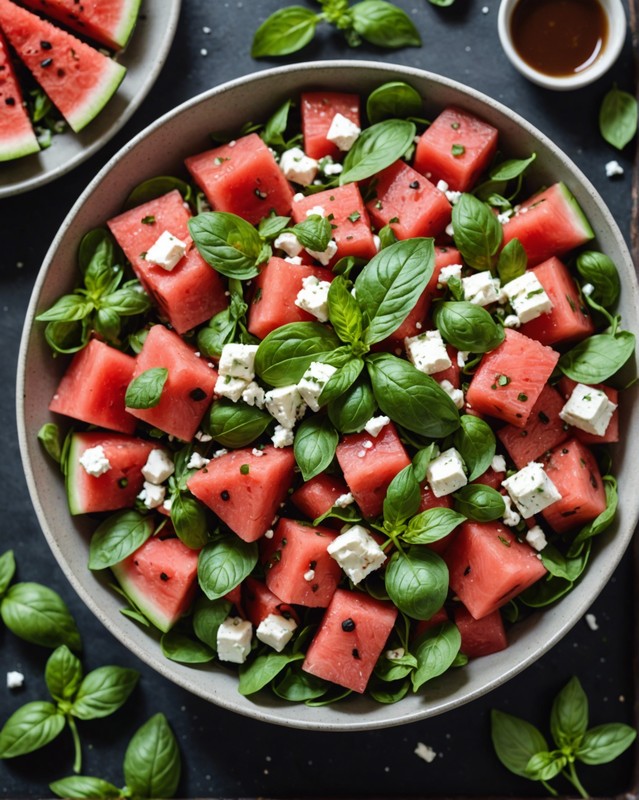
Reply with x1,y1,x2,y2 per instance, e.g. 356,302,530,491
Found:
38,82,634,704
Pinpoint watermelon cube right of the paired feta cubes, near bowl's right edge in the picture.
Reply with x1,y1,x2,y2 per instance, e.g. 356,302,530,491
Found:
520,256,595,344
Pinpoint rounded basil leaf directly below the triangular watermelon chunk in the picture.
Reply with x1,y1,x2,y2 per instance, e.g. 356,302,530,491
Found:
197,534,257,600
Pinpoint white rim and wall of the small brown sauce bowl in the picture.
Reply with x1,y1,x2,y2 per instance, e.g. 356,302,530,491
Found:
497,0,626,91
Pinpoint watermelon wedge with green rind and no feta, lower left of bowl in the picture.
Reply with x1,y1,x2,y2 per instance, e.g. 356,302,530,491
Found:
111,536,198,632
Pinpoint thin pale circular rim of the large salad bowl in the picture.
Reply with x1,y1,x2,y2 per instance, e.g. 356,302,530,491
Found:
16,59,639,731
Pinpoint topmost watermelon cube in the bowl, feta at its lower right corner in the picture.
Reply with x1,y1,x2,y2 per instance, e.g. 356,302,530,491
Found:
300,92,361,160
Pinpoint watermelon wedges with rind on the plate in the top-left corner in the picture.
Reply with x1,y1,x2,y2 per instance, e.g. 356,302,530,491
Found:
0,0,141,161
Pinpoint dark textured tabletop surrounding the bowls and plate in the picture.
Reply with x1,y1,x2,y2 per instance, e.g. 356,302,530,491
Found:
0,0,635,798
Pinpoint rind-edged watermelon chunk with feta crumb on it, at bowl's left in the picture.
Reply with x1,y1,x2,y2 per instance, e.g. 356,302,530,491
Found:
66,432,155,514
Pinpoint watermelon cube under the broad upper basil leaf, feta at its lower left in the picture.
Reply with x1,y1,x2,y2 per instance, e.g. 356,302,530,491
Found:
292,183,377,261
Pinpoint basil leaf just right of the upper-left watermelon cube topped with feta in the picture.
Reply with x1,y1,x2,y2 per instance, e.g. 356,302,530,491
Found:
188,211,265,280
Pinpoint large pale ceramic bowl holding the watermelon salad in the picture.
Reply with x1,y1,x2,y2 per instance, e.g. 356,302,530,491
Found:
17,61,639,730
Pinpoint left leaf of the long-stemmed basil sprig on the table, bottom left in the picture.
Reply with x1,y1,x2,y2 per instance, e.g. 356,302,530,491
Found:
0,700,65,758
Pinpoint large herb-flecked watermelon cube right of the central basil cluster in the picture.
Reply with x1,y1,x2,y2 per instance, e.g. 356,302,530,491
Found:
466,329,559,428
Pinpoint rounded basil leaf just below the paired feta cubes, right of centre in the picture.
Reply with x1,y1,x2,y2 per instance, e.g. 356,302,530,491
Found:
435,300,504,353
